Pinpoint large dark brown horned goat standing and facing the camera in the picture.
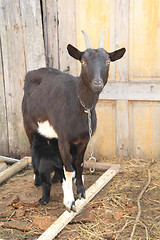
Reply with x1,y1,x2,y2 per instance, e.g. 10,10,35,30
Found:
22,33,125,210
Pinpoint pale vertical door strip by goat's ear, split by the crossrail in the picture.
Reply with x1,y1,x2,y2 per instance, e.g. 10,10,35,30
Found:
115,0,129,157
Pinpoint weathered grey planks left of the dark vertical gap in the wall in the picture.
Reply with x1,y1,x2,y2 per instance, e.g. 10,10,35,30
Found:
0,0,45,157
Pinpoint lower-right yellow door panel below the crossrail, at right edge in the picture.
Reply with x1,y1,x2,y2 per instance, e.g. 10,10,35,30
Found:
129,101,160,159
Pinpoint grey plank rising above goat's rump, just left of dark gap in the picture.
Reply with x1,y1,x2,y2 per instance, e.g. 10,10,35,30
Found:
20,0,46,71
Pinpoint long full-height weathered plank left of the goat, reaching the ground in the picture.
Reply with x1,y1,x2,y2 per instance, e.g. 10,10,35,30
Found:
0,0,25,156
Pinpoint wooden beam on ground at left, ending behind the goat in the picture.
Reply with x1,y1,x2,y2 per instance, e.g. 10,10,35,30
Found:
0,157,31,184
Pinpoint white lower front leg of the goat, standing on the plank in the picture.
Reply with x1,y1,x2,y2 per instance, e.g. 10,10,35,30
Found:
62,168,75,210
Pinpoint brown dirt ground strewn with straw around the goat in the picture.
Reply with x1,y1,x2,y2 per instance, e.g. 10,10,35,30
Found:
0,159,160,240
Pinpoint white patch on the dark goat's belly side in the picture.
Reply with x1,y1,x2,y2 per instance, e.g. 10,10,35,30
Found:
37,121,58,138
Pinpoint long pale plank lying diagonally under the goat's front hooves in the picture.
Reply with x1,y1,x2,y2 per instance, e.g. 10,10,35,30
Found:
38,164,120,240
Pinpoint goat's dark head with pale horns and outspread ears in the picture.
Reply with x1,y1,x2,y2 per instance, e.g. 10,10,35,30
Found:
67,31,126,94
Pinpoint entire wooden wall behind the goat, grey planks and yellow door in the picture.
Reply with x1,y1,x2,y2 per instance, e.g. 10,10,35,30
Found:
0,0,160,159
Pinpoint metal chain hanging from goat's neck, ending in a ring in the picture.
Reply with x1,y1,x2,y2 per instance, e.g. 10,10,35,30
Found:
78,96,96,173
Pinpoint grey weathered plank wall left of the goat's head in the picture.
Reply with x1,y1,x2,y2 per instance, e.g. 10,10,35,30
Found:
0,0,77,158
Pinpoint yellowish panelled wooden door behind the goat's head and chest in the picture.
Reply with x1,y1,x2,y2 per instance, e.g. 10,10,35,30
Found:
76,0,160,159
